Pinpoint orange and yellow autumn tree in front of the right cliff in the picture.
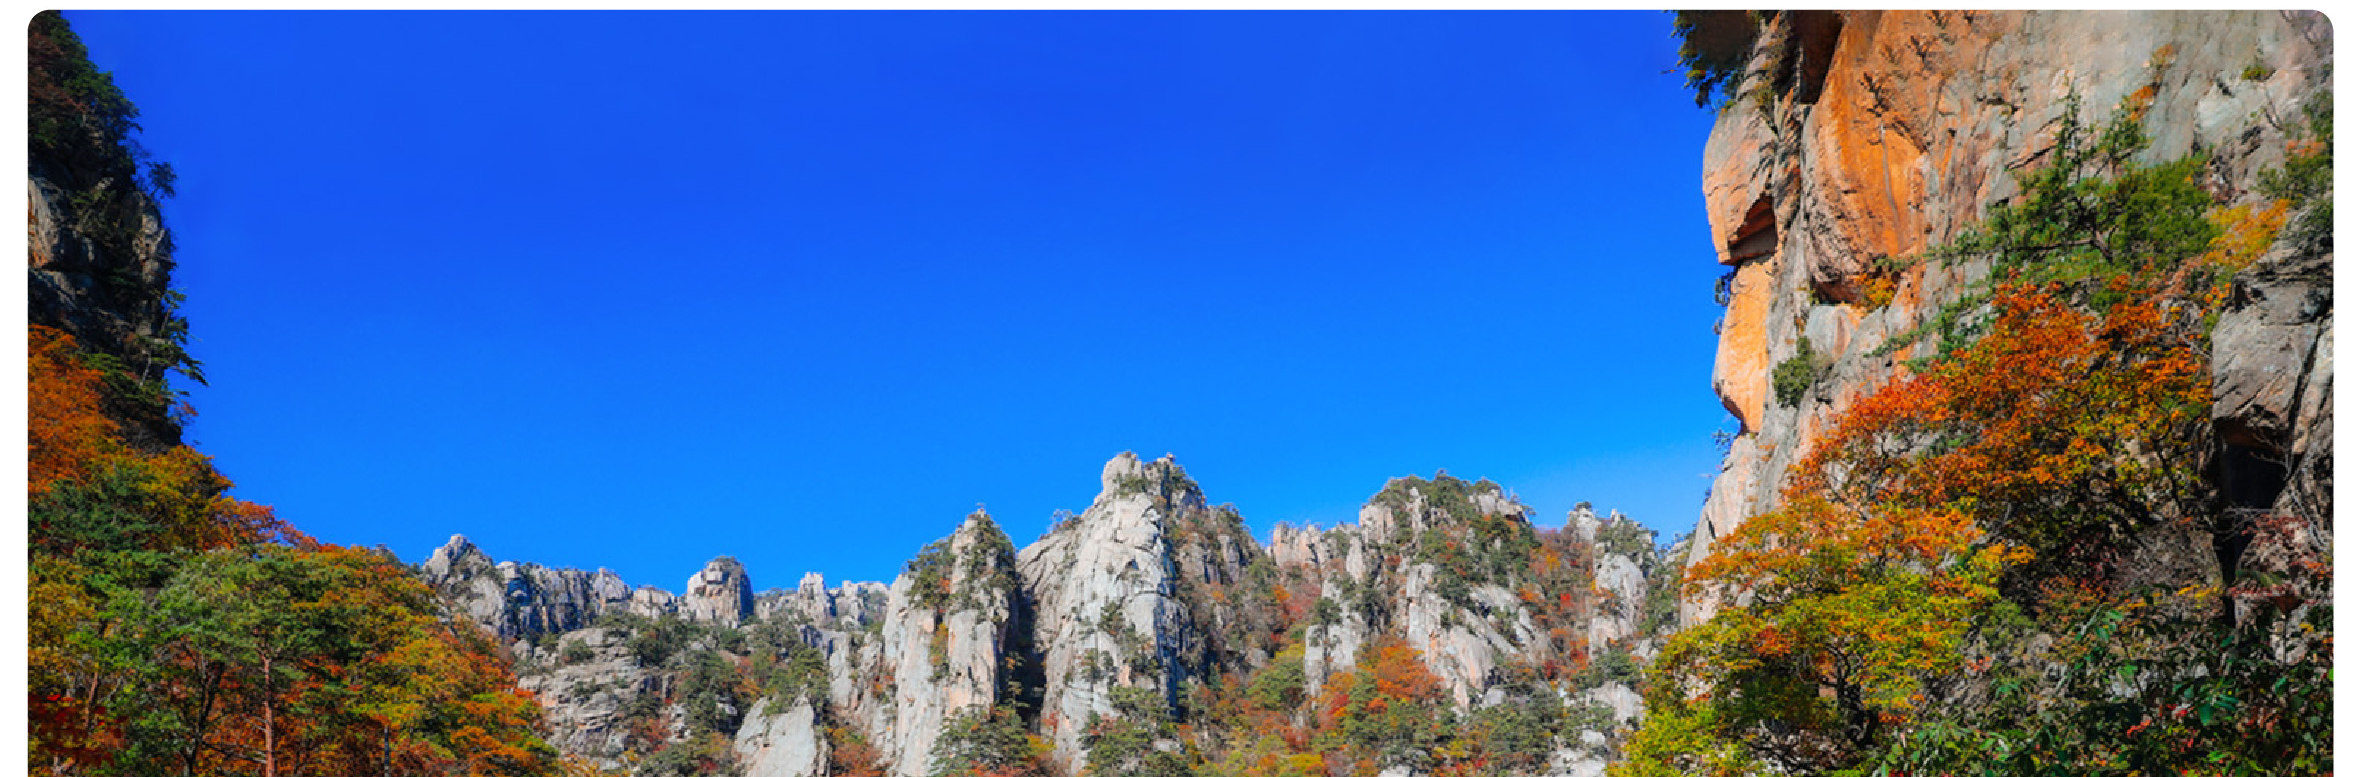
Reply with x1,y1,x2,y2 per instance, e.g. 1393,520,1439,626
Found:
1627,283,2208,775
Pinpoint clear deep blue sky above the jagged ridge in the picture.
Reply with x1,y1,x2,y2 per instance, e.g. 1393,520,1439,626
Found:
68,12,1726,590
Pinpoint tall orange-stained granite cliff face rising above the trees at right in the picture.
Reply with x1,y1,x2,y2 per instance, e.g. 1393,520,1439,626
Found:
1683,12,2333,621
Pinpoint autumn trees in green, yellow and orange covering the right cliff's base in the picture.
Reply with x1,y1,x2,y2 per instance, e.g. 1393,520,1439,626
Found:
1617,95,2328,775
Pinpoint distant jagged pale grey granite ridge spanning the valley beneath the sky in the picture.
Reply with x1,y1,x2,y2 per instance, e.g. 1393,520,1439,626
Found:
420,453,1672,777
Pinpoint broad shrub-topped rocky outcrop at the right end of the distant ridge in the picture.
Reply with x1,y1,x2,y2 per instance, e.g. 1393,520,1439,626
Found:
1270,475,1674,775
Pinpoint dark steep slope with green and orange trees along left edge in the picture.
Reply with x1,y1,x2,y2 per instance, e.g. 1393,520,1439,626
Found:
26,12,569,775
